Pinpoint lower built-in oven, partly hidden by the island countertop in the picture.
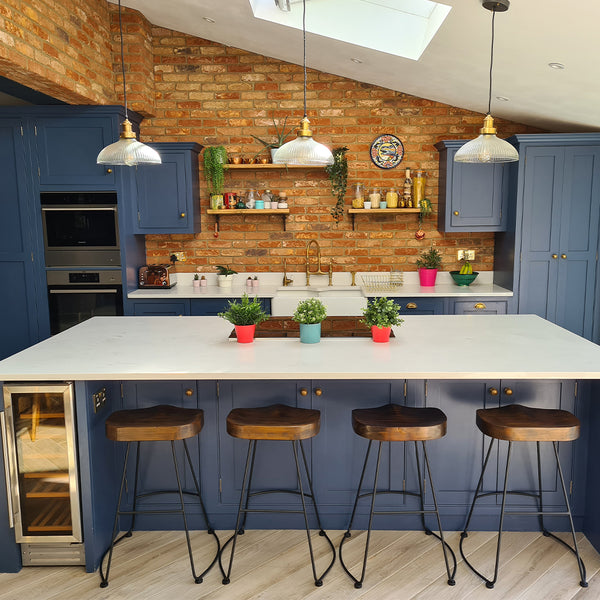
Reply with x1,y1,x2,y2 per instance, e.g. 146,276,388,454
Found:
46,269,123,335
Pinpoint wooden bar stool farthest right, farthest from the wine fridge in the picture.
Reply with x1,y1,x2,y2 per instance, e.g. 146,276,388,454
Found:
460,404,587,589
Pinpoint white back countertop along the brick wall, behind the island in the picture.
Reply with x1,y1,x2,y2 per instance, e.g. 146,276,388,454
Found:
127,271,513,300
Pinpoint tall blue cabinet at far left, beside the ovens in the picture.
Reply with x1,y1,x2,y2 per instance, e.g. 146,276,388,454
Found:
0,118,49,359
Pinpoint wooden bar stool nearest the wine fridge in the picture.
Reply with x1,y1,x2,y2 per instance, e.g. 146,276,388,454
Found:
100,404,221,588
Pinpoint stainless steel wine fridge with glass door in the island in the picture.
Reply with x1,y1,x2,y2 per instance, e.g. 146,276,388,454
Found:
1,383,83,565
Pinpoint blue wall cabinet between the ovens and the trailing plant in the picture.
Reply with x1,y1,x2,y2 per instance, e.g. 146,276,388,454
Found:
133,142,202,234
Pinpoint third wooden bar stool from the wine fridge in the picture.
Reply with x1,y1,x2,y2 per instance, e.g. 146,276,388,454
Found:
340,404,456,589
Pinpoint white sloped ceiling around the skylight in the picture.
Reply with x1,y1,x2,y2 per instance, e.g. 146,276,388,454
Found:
115,0,600,132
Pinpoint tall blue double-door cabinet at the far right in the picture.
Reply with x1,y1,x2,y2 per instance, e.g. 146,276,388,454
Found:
517,142,600,339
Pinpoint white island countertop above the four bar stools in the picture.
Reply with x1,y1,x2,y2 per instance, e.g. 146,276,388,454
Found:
0,315,600,381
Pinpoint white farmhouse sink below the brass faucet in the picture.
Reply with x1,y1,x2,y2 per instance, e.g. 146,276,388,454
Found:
271,285,367,317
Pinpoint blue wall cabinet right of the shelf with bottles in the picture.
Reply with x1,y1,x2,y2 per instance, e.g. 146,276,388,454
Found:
435,140,509,232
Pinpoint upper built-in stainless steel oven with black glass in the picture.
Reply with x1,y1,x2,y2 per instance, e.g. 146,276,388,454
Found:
40,192,121,267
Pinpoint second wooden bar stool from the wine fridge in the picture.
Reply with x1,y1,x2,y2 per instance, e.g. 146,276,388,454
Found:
221,404,335,587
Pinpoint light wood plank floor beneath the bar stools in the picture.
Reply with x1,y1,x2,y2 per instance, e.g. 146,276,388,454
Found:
0,530,600,600
